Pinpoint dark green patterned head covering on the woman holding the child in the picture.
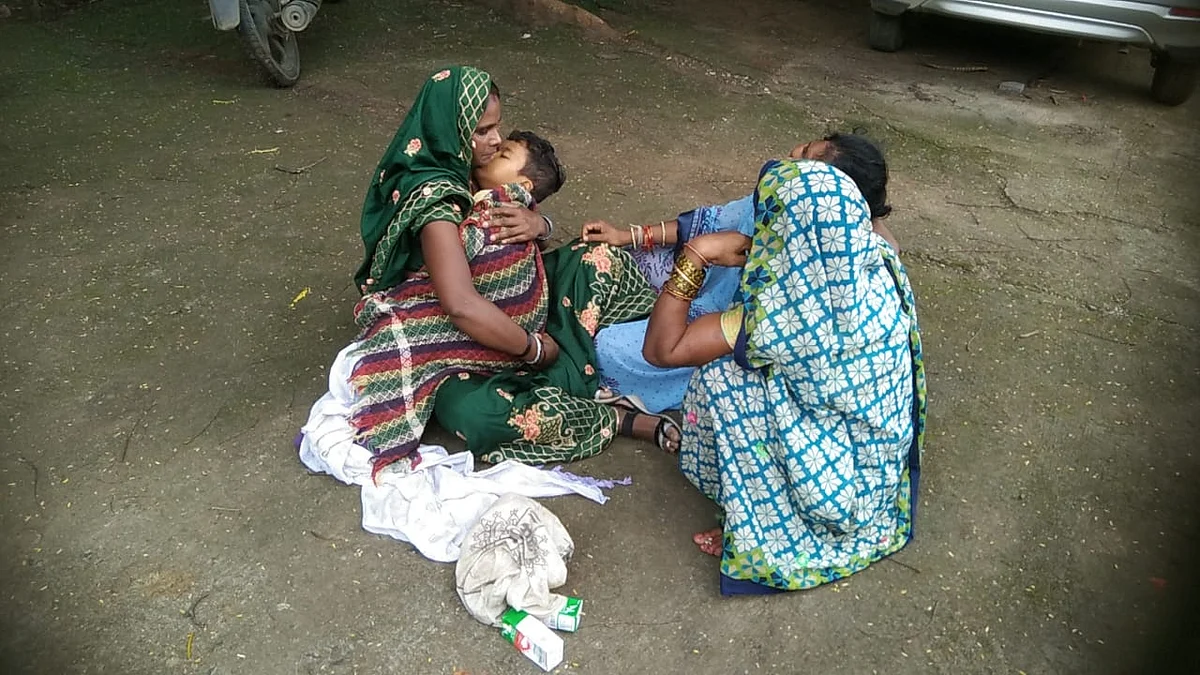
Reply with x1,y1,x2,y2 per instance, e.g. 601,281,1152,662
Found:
354,66,492,291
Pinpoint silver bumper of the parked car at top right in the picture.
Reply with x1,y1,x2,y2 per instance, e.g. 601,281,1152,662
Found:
872,0,1200,55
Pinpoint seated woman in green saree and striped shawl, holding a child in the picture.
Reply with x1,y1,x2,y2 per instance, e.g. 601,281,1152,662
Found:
314,66,666,471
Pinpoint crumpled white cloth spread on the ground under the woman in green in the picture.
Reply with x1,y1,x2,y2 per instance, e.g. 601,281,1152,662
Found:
300,344,608,562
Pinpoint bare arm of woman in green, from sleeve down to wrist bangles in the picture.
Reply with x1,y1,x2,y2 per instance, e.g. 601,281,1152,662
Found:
421,220,529,358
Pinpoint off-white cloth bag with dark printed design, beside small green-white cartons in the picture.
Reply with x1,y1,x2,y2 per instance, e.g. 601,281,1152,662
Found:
455,487,575,626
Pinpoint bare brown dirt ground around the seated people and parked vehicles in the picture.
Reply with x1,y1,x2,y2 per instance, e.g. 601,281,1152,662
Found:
0,0,1200,675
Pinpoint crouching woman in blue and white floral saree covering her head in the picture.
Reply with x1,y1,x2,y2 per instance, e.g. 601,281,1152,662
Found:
644,160,925,595
